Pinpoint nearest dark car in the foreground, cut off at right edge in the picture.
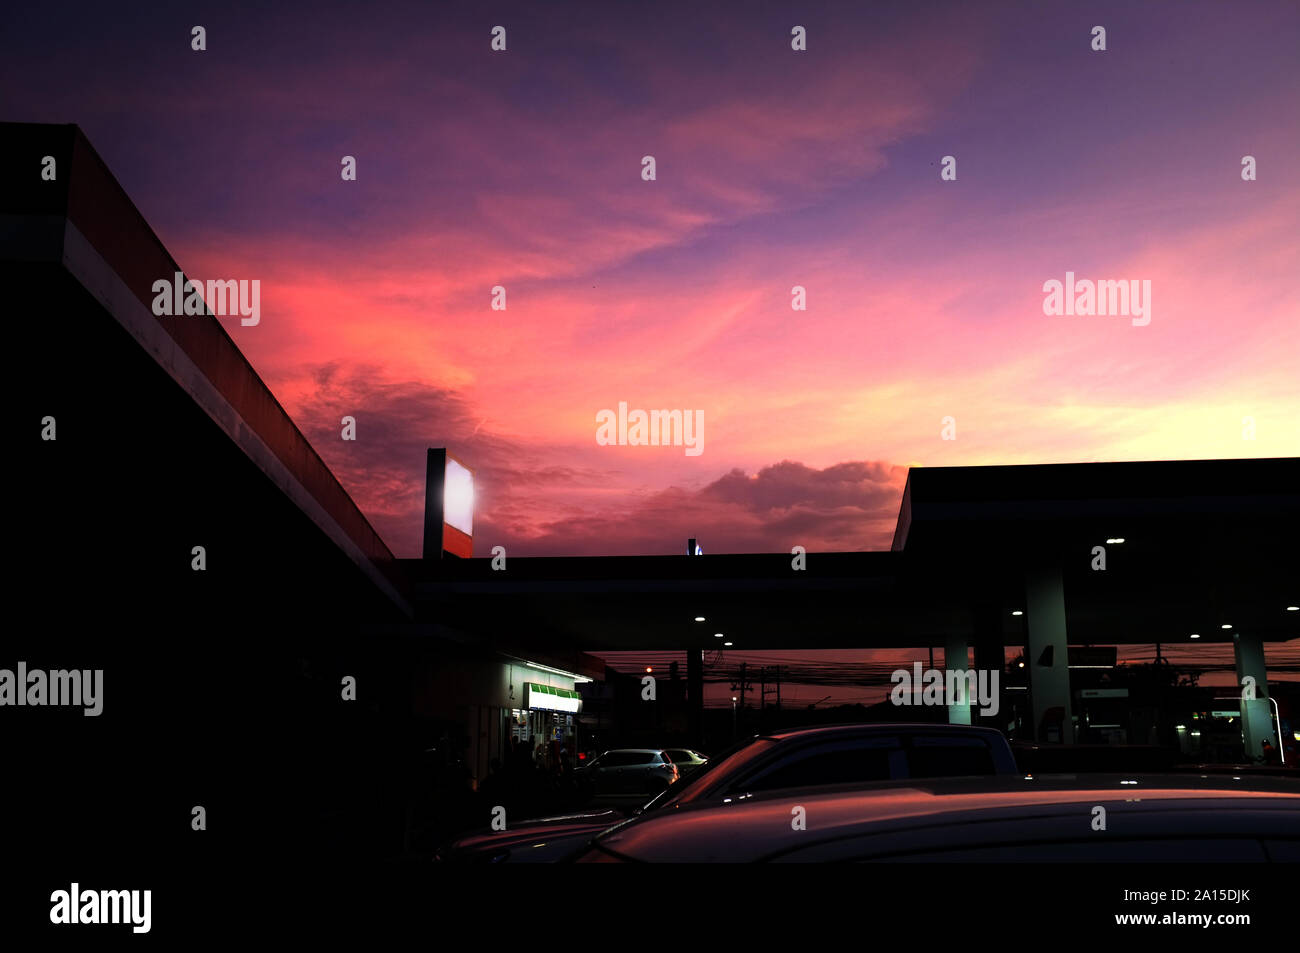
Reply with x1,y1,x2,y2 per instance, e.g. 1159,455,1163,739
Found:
572,774,1300,863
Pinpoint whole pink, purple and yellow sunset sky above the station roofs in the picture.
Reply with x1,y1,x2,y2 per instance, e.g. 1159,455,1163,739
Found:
0,1,1300,556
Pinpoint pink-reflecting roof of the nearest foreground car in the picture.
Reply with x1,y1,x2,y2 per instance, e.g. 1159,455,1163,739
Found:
595,775,1300,862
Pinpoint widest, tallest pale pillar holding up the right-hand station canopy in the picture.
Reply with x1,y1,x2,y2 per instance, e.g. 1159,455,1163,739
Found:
1024,568,1074,745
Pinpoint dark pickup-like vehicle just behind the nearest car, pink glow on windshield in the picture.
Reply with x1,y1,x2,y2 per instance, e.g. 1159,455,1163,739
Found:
436,724,1019,862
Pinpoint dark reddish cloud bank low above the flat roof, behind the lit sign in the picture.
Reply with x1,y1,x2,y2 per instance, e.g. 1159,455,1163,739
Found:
293,363,906,556
